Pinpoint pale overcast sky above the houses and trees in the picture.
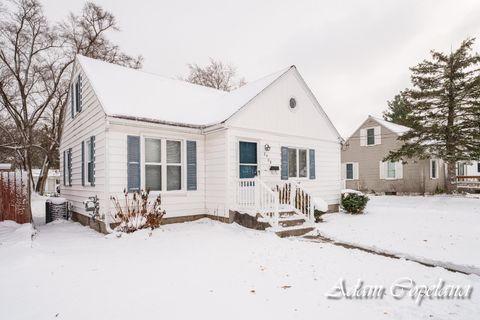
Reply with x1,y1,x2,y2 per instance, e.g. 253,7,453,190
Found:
41,0,480,136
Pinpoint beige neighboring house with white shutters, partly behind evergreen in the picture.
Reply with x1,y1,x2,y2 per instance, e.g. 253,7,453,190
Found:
342,116,445,194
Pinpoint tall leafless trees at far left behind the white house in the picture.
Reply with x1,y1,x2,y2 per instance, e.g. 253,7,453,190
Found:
0,0,142,219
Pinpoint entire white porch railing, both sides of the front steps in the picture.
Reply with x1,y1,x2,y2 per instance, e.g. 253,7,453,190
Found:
235,177,314,226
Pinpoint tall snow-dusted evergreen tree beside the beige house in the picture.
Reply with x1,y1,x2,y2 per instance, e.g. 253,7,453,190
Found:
387,39,480,192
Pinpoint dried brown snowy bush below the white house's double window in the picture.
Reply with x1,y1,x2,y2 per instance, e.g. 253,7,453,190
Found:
110,190,165,233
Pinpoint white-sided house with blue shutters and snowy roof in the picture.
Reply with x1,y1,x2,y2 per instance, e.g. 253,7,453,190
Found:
60,56,342,235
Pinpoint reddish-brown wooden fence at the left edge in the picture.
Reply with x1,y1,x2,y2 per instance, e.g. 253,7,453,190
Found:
0,171,31,223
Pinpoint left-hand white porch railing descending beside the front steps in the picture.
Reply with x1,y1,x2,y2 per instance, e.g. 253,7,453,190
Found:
235,177,280,227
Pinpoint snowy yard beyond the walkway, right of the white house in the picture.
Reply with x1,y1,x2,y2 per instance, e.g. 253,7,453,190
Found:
317,196,480,274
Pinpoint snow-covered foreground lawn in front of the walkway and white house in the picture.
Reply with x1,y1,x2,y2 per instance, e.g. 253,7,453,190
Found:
0,215,480,320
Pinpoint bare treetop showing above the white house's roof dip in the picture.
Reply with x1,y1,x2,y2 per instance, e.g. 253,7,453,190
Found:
184,58,246,91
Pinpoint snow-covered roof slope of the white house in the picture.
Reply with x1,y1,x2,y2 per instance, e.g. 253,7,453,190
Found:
77,55,291,126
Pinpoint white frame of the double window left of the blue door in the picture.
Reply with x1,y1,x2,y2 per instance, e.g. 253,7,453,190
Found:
140,135,187,196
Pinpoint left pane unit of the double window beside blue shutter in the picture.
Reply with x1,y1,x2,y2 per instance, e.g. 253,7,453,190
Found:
145,139,162,191
